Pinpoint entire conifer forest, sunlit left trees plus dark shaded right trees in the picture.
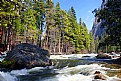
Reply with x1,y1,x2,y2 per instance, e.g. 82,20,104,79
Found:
0,0,121,54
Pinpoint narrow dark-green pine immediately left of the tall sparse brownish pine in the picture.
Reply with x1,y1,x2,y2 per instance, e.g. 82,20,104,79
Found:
33,0,46,47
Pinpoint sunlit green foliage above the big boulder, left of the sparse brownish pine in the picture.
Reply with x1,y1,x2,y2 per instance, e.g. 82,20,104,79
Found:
0,0,45,45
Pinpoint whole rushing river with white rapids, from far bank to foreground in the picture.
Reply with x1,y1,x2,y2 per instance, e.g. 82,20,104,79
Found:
0,54,121,81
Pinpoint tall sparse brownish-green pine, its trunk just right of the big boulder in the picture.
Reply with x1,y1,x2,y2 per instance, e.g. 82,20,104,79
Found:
44,0,55,52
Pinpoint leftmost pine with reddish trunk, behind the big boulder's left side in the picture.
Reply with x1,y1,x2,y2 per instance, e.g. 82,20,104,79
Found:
0,0,21,50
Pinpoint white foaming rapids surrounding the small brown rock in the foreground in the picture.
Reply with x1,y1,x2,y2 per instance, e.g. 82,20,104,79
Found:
43,64,119,81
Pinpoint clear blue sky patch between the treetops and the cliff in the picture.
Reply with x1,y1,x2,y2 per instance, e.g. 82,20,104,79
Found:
53,0,102,30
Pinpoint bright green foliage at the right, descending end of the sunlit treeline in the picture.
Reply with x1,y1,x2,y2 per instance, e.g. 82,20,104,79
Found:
59,7,90,53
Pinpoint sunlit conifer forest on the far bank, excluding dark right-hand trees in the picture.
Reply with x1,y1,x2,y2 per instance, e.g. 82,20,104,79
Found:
0,0,95,54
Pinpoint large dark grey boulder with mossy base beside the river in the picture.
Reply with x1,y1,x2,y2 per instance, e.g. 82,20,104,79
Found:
1,43,51,69
